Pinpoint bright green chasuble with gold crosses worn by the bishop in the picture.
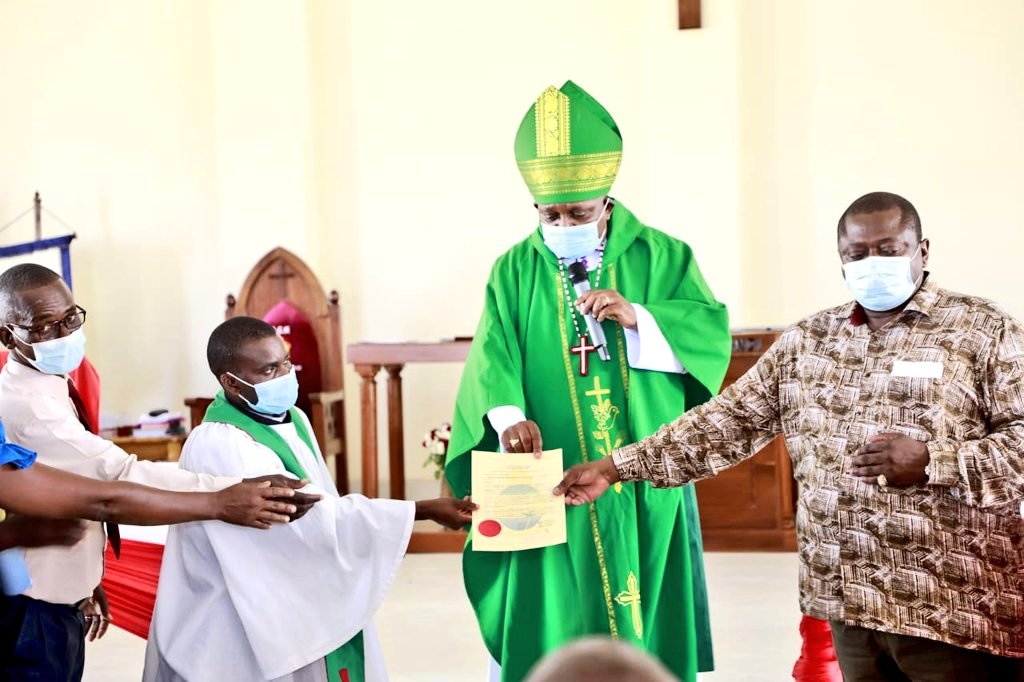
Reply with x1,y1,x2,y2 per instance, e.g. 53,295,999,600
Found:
445,203,730,682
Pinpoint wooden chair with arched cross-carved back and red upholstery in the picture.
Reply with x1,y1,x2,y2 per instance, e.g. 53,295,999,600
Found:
185,247,349,495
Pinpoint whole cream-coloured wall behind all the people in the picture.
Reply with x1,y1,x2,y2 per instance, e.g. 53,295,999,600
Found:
0,0,1024,489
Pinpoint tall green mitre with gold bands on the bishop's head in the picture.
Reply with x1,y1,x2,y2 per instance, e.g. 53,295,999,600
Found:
515,81,623,204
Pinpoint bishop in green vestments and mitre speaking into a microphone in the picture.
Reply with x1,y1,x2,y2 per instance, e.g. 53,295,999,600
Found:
446,81,730,682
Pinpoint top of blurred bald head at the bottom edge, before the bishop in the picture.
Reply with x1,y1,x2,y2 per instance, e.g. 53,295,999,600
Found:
526,637,678,682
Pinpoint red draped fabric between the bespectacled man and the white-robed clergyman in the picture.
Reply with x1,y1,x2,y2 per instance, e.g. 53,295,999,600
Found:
103,540,164,639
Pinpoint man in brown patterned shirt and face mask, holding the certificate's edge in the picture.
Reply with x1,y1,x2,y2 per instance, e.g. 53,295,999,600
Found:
555,193,1024,682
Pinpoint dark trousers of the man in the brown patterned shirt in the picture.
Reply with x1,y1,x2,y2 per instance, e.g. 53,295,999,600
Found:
830,621,1024,682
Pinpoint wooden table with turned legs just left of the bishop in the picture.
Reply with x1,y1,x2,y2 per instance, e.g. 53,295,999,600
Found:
346,339,471,552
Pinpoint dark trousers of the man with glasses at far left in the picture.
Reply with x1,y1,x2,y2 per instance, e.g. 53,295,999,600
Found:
0,595,85,682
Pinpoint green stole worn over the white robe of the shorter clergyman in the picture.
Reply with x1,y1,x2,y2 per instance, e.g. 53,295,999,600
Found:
203,391,366,682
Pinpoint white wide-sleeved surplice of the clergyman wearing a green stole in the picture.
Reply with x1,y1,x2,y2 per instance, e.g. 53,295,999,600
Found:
145,424,415,682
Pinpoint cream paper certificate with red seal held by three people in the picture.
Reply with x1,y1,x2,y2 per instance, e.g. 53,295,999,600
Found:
472,450,565,552
